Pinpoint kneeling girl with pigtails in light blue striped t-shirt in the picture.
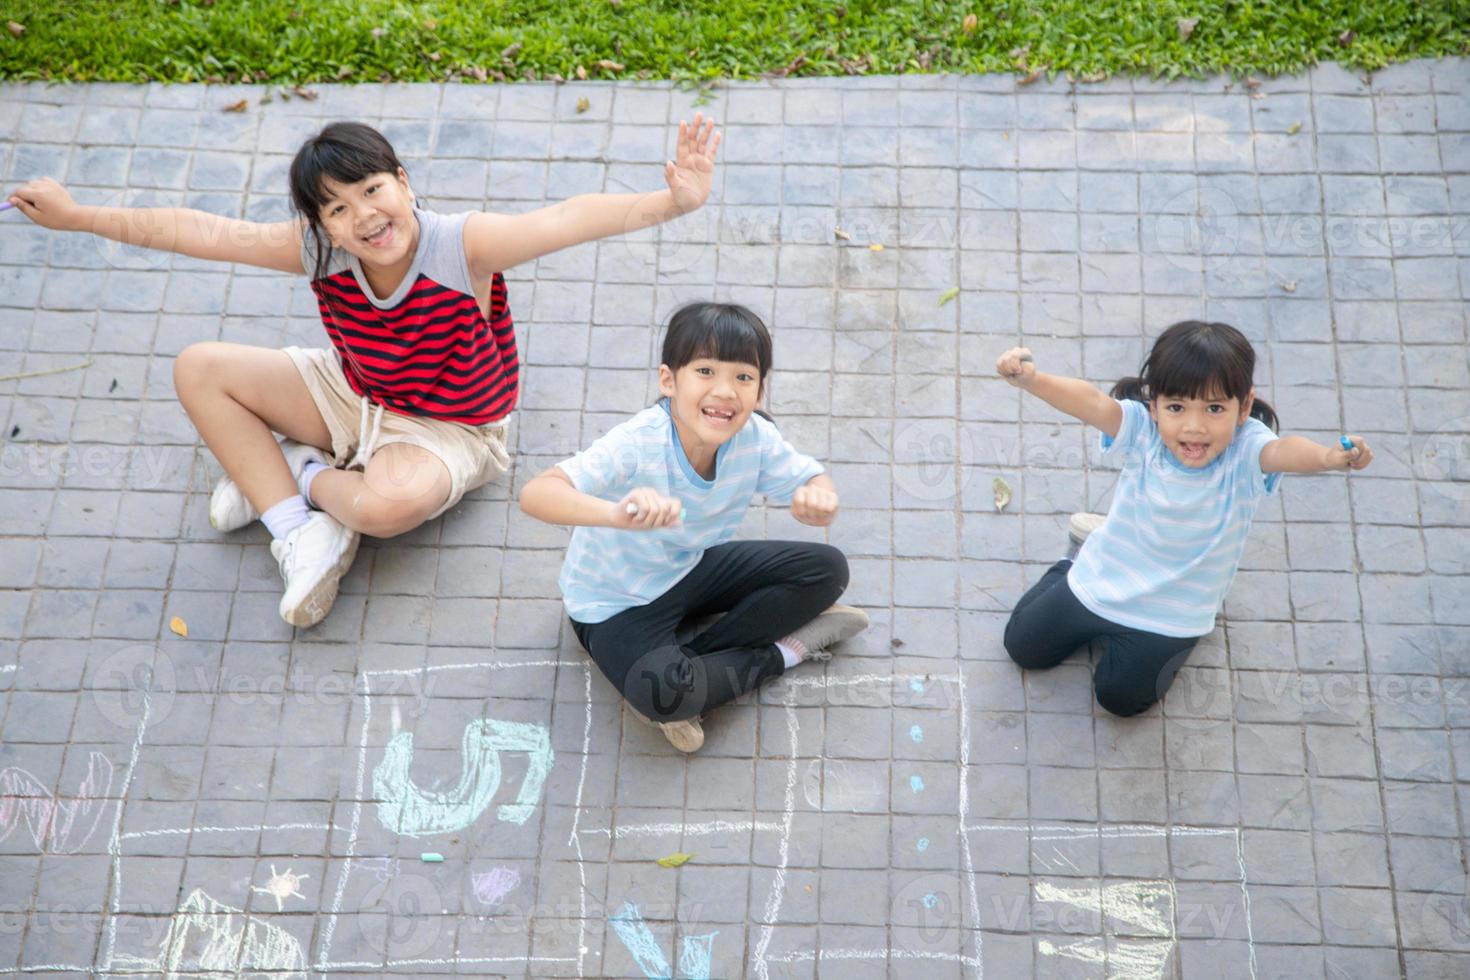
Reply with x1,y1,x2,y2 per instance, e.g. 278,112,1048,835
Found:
995,320,1373,716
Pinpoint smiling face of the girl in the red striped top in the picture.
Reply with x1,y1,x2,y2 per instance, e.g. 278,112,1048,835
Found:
318,167,419,266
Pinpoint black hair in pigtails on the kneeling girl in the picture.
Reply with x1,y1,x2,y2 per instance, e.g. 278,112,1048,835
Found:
1111,320,1277,432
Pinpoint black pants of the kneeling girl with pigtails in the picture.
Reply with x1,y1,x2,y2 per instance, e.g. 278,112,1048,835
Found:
1005,558,1200,716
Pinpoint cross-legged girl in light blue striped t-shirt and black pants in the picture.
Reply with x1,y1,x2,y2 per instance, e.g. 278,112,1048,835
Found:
520,303,867,752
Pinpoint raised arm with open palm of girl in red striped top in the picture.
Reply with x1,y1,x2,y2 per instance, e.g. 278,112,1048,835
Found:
465,115,720,276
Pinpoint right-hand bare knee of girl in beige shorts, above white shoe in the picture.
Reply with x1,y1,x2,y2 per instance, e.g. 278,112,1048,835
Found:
312,442,450,538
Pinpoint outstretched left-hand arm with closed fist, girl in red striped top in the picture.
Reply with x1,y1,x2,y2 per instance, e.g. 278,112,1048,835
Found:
7,176,303,273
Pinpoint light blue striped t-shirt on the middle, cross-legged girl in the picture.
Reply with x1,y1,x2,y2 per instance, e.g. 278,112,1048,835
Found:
559,400,822,623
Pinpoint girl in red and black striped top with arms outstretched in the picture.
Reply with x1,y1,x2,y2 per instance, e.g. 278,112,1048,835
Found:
9,115,720,626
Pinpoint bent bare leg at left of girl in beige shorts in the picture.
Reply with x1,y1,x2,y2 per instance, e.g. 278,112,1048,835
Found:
173,342,335,516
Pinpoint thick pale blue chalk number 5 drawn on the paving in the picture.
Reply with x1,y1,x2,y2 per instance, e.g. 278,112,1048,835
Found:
372,718,556,837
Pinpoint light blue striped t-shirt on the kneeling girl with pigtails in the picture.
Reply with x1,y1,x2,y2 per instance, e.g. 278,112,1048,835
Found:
1067,400,1282,636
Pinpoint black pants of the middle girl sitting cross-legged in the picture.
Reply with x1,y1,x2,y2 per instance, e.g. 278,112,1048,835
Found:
572,541,847,721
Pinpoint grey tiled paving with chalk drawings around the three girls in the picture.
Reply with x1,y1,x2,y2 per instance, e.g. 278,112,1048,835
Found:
0,60,1470,980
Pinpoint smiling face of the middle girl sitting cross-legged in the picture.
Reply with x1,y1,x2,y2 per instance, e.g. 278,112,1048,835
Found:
659,357,761,467
